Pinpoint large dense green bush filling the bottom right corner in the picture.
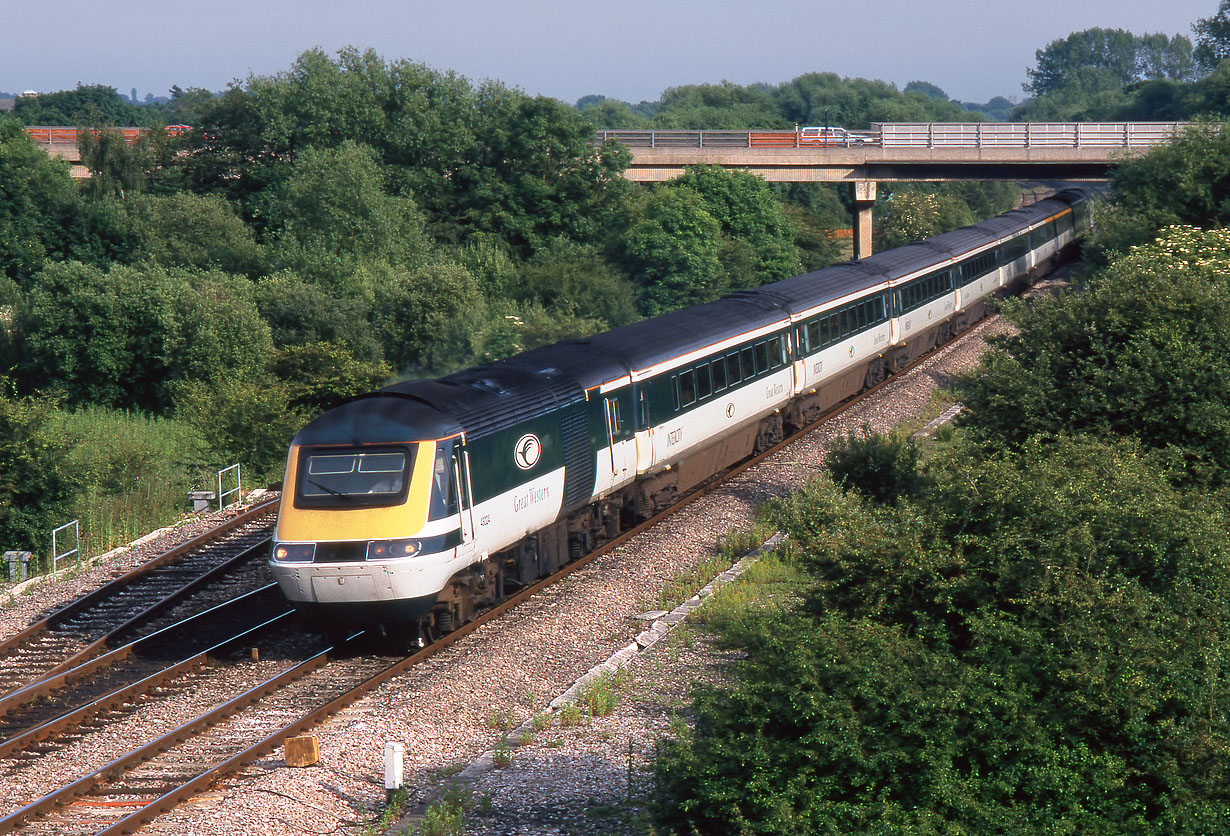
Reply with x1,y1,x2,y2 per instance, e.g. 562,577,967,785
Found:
654,441,1230,835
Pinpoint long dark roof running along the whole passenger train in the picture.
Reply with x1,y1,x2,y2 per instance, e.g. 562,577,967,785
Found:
295,191,1085,445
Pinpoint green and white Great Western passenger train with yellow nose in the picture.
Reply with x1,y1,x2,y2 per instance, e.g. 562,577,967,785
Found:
269,188,1096,642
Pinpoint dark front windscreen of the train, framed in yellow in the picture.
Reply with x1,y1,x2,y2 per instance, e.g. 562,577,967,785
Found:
295,448,415,508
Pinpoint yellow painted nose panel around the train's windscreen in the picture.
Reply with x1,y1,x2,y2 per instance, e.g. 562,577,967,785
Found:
277,441,435,542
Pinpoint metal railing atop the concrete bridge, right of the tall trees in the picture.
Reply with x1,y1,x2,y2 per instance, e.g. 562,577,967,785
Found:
593,122,1205,149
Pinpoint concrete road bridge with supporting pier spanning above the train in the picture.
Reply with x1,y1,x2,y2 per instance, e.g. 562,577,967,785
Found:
594,122,1189,258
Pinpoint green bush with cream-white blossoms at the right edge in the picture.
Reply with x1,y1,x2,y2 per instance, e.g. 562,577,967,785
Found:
958,223,1230,484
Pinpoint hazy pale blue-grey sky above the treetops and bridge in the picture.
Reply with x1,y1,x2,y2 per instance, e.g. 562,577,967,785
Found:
0,0,1218,103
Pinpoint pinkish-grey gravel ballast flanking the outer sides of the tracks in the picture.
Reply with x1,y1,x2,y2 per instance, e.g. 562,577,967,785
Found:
0,318,1006,836
